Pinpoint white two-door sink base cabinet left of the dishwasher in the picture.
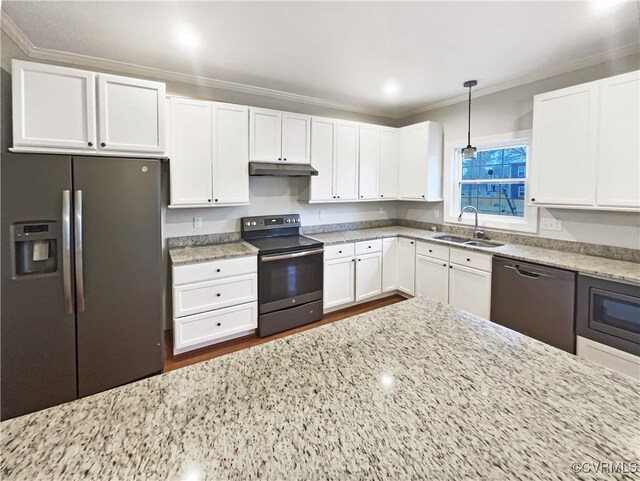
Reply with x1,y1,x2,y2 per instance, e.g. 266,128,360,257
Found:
416,242,491,319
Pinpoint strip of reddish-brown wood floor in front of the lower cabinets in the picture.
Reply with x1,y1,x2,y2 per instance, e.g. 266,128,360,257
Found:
164,294,405,372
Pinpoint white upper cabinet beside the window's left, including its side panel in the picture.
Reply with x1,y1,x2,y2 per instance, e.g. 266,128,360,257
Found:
398,122,442,201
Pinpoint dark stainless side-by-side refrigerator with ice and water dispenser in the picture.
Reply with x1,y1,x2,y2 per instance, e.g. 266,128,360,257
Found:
0,154,162,419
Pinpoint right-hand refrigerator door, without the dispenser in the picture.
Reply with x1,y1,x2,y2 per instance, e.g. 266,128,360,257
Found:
73,157,162,396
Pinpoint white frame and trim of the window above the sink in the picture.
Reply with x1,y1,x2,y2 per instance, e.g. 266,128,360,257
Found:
444,130,538,232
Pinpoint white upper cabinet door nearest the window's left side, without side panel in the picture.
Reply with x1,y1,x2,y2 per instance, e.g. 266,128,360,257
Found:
398,124,428,200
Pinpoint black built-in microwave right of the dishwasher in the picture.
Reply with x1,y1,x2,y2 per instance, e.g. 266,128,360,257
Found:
577,276,640,355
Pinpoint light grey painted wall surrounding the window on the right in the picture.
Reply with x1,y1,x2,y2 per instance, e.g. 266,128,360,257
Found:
398,55,640,249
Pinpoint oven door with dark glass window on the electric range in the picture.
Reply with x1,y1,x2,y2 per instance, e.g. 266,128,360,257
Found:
258,248,324,314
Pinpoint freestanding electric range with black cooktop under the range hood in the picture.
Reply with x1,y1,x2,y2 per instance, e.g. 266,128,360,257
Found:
242,214,324,337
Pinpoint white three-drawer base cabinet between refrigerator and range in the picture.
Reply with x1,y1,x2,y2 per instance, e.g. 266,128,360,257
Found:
172,256,258,354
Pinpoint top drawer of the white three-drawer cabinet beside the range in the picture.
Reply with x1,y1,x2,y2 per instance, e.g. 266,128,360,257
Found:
173,256,258,286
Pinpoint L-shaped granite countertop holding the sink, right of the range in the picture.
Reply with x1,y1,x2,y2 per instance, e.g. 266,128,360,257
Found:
308,226,640,283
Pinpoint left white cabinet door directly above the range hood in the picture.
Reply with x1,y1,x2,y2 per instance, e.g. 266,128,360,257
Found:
249,108,282,162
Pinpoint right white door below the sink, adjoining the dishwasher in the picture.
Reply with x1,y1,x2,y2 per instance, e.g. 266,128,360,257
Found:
449,264,491,319
